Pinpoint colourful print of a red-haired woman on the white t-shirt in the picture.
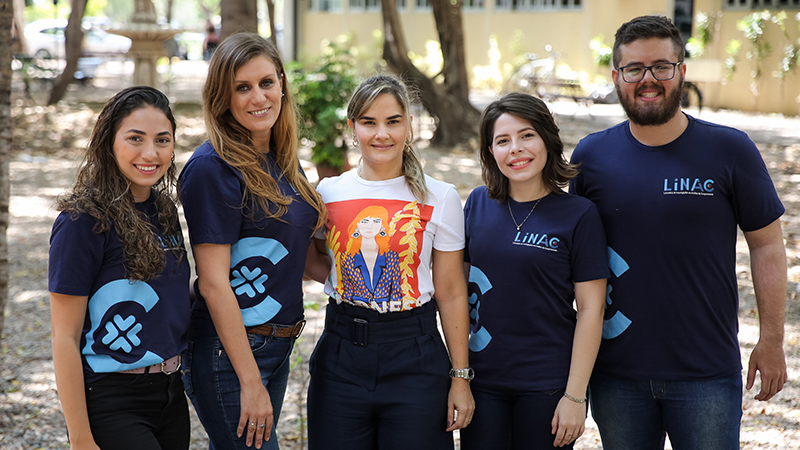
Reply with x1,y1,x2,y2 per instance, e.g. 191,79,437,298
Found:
327,199,433,312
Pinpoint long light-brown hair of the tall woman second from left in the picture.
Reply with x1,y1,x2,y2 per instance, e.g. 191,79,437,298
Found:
203,33,326,230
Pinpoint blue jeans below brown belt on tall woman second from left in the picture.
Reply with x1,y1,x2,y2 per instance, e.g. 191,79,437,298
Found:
182,334,294,450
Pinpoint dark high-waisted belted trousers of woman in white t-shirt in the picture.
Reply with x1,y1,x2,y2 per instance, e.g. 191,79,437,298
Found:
308,301,453,450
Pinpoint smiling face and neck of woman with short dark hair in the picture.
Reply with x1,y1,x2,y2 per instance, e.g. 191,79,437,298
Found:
491,113,547,201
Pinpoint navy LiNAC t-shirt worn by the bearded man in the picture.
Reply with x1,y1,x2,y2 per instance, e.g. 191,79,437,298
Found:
570,116,784,380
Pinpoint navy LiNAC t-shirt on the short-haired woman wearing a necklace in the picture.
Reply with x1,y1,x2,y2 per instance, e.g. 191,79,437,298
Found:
464,186,608,391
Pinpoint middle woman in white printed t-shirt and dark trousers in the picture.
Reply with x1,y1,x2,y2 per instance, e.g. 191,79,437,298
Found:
308,75,474,450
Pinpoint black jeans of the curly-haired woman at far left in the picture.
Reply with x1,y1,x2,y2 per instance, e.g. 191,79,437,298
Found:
86,373,190,450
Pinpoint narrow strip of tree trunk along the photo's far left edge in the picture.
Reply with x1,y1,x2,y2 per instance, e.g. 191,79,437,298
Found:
0,0,14,339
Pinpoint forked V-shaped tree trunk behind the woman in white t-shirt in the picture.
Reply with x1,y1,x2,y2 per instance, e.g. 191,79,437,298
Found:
381,0,480,147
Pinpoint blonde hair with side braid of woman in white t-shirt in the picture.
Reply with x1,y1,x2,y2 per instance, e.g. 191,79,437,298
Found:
347,75,428,203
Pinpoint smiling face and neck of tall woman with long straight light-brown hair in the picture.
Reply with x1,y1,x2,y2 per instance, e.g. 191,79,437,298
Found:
230,56,283,150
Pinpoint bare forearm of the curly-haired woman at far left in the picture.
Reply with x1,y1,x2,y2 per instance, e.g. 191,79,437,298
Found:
52,340,94,447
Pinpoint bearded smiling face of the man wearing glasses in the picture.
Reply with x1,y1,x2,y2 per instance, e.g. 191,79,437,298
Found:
611,38,686,126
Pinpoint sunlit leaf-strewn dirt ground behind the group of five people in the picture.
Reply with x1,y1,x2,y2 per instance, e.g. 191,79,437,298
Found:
0,64,800,450
